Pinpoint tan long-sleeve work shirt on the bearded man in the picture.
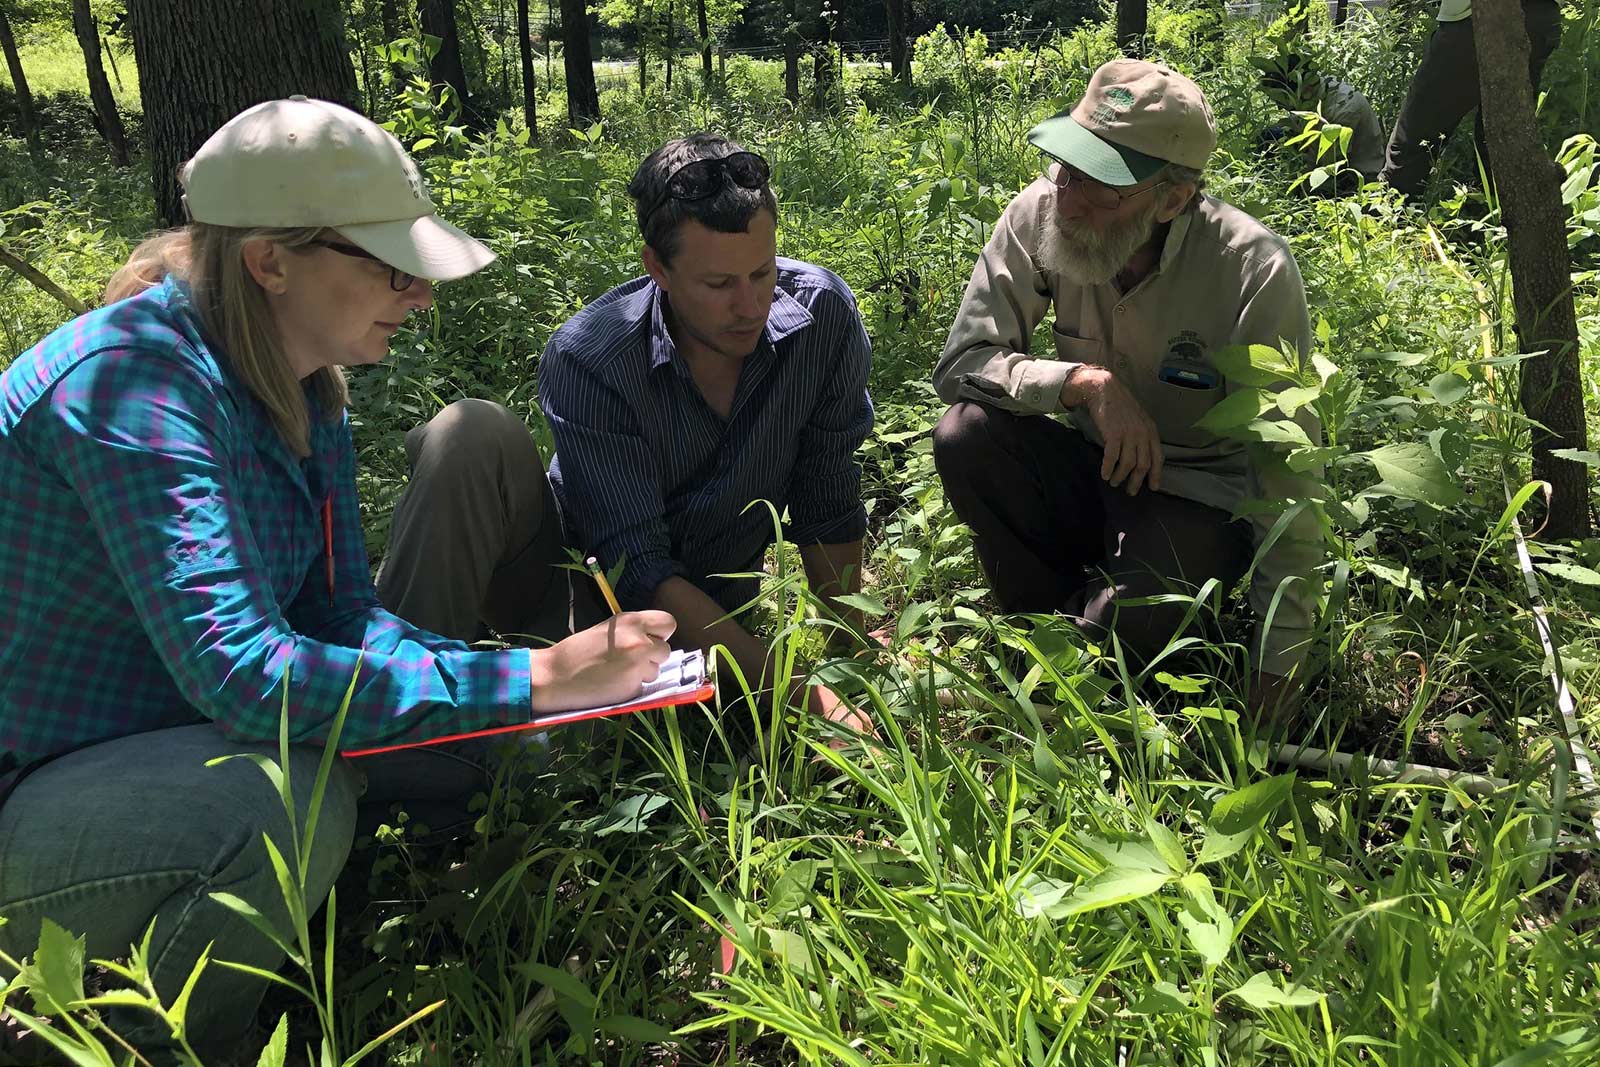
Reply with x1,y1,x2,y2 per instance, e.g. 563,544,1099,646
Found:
933,178,1323,673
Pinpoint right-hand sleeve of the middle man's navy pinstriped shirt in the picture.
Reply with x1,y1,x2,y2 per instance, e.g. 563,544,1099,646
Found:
784,289,872,544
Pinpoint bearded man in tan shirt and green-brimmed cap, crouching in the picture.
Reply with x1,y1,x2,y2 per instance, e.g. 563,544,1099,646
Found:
933,59,1323,709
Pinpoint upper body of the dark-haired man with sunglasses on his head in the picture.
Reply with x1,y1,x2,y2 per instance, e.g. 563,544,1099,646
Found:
539,134,872,742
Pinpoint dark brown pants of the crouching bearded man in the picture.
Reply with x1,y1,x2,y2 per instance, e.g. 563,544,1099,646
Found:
933,402,1251,659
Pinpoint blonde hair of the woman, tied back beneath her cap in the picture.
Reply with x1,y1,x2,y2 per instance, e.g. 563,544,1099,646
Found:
106,222,350,459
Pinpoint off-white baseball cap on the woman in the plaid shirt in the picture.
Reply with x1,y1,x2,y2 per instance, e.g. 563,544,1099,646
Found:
178,96,494,282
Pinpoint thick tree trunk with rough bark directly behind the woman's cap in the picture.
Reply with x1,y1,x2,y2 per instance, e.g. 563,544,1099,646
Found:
128,0,358,226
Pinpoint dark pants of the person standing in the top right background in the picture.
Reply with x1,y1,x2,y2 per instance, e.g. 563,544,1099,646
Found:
1381,0,1562,197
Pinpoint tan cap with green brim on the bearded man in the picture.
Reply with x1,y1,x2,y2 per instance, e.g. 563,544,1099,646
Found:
1027,59,1216,186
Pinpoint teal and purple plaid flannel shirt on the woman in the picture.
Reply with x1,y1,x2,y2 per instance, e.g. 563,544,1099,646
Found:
0,278,530,773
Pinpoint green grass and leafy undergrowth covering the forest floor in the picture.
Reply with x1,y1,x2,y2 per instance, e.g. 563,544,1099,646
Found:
9,4,1600,1067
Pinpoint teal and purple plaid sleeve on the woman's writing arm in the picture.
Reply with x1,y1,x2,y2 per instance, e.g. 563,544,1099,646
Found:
45,350,530,745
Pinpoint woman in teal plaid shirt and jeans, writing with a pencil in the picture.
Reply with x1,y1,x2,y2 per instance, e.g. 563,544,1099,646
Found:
0,98,674,1062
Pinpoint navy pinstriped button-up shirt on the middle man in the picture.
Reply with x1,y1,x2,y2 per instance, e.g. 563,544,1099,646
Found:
539,259,872,609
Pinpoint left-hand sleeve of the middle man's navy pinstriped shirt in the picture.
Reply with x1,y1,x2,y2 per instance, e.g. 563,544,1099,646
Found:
539,341,686,608
